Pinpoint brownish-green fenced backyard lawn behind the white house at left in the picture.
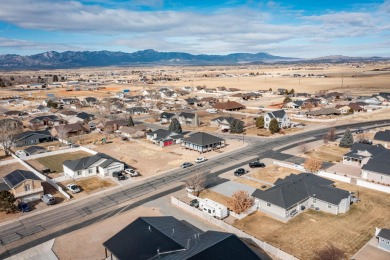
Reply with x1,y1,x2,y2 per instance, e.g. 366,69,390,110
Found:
35,152,92,173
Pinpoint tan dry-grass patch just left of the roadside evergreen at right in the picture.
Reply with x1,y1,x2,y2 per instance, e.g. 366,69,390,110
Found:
307,145,349,162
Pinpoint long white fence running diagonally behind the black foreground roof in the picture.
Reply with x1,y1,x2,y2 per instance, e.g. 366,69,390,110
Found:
171,196,298,260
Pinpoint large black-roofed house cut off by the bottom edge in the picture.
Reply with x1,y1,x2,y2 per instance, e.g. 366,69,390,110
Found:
102,216,261,260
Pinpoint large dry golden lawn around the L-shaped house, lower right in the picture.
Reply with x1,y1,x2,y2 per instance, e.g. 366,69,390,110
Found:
234,182,390,259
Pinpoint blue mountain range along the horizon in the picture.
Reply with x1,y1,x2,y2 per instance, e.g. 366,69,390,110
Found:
0,50,388,70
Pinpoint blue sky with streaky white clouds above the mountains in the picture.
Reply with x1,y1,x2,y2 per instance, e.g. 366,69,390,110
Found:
0,0,390,58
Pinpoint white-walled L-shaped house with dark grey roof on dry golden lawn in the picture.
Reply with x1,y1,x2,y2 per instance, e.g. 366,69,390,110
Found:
252,173,351,220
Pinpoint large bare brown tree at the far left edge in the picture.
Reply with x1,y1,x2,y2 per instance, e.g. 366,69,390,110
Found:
0,119,23,156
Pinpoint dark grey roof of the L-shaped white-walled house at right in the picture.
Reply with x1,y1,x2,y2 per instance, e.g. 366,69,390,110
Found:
252,173,349,209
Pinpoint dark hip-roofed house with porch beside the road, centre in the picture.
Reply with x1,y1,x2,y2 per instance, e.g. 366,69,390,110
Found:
181,132,226,153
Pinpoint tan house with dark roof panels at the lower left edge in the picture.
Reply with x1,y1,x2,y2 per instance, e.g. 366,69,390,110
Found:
0,170,43,202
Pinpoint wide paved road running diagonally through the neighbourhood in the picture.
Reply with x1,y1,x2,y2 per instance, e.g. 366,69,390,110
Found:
0,120,390,259
